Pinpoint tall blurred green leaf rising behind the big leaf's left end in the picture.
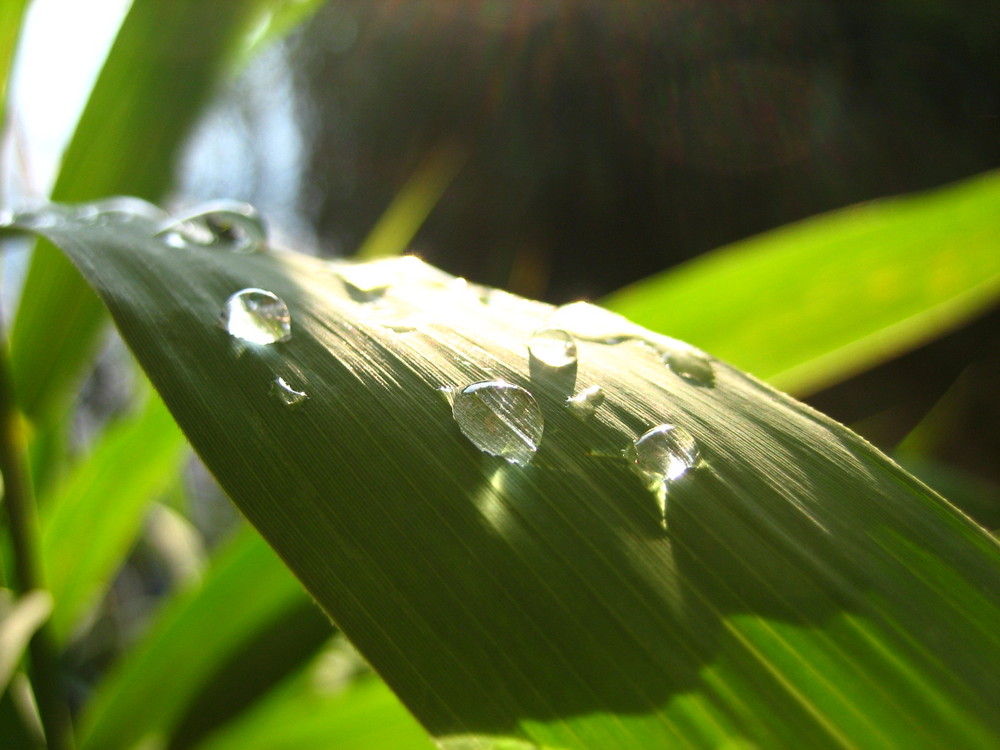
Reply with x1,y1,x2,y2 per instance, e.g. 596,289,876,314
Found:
11,0,324,419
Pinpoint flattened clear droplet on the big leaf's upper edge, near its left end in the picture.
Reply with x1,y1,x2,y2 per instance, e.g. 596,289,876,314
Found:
156,201,267,253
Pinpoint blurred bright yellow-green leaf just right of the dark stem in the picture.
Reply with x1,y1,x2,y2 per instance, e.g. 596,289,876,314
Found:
39,394,187,642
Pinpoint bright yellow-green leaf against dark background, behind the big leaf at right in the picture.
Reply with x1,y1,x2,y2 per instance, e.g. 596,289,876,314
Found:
604,172,1000,393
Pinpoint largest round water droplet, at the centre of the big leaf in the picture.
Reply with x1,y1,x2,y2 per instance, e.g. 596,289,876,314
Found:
452,380,544,464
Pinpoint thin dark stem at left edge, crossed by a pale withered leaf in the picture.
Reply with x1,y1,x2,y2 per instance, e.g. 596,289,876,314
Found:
0,310,73,750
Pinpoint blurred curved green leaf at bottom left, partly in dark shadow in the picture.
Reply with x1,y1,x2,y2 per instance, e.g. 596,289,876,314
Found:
79,530,316,750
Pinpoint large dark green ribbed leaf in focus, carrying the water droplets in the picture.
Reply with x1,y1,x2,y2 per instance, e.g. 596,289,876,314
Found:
11,206,1000,748
